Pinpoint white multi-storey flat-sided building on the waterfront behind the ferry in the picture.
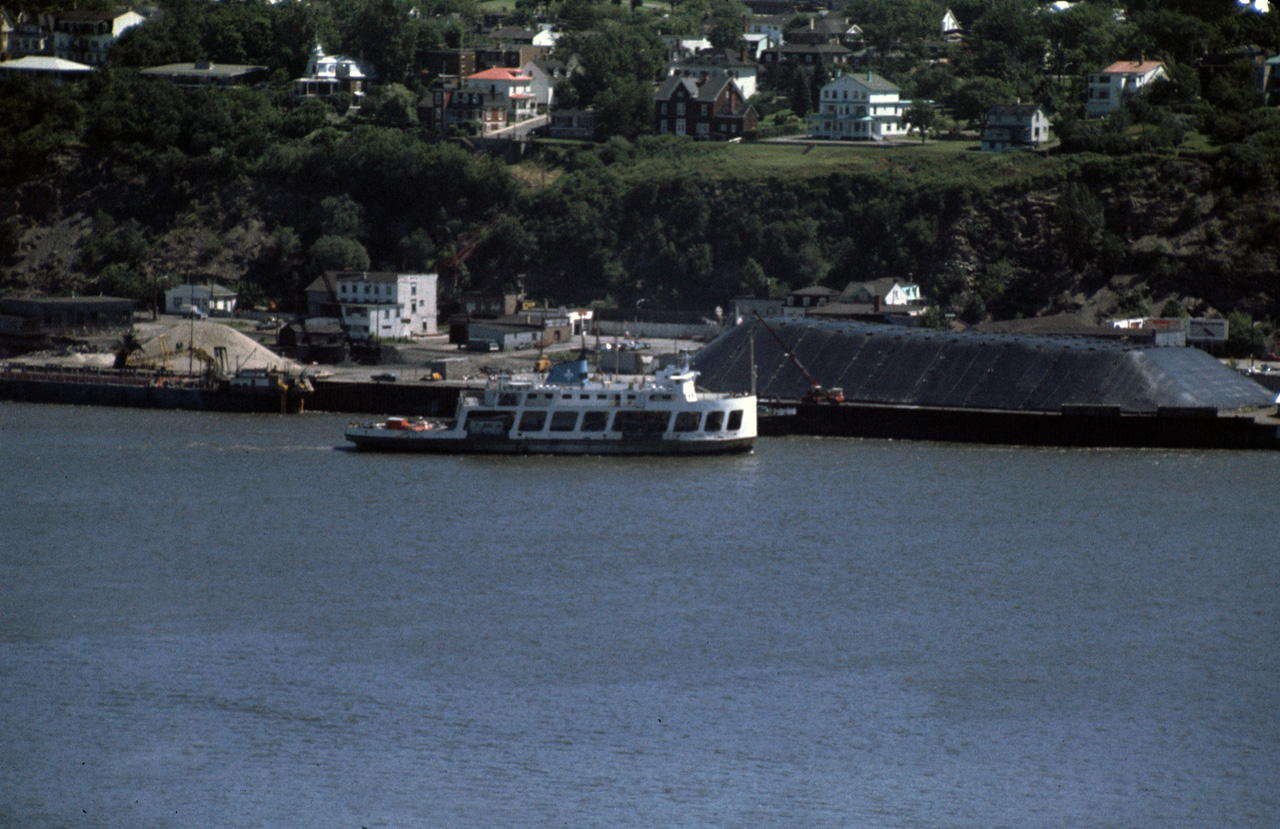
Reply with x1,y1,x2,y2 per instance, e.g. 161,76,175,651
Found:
333,271,439,340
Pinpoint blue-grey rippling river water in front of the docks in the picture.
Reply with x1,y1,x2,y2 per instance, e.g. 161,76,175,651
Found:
0,404,1280,828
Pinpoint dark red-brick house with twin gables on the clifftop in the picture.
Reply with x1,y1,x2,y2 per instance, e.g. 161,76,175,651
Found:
654,75,759,139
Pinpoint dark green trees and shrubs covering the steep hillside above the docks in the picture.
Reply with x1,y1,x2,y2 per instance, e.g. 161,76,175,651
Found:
0,0,1280,342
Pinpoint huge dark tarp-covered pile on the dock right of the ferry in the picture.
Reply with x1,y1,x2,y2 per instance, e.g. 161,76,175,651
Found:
692,319,1275,412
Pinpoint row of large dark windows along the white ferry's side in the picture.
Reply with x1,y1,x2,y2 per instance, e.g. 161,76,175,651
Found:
465,409,742,435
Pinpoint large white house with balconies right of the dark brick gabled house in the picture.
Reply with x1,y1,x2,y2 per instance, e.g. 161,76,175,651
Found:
806,72,911,141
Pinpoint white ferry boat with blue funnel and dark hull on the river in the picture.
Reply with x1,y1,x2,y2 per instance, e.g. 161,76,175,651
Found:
346,359,756,454
